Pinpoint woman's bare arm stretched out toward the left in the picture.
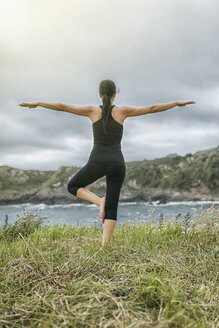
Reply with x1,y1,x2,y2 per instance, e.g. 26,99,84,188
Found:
19,101,93,117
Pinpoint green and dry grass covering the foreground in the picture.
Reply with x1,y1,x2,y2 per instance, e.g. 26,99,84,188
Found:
0,207,219,328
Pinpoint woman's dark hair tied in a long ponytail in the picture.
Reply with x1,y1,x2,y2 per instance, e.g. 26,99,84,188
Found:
99,80,116,134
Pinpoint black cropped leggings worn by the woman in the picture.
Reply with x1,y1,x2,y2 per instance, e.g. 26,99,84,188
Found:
67,161,126,220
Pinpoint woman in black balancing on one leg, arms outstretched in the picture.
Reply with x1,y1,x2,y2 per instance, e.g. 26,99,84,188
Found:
19,80,195,245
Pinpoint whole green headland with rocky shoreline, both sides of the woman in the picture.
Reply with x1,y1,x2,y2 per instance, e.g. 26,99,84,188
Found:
0,147,219,205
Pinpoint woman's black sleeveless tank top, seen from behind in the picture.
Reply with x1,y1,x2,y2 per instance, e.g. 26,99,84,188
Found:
89,105,125,164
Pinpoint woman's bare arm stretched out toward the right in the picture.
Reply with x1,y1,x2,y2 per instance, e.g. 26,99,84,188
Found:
121,101,195,117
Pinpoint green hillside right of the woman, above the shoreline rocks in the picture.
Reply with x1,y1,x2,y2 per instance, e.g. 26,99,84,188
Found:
126,147,219,193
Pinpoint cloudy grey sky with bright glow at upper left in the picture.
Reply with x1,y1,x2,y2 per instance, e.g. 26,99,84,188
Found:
0,0,219,170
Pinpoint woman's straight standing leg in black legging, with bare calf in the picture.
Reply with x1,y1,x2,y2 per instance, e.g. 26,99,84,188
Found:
102,163,126,246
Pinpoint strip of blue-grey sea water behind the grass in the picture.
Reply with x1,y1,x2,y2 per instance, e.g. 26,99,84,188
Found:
0,201,219,226
